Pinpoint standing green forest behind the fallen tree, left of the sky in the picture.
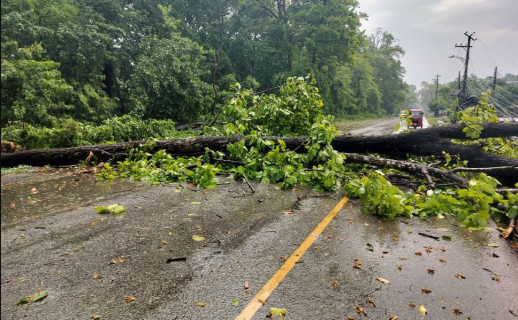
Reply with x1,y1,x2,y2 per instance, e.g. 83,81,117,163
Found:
1,0,415,131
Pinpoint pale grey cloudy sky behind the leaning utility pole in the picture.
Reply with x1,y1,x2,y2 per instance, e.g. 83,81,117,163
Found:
358,0,518,88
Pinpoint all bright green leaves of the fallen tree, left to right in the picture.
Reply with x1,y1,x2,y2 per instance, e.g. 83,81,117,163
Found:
100,77,518,229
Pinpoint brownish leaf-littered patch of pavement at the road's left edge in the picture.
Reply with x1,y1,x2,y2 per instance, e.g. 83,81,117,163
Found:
1,169,143,228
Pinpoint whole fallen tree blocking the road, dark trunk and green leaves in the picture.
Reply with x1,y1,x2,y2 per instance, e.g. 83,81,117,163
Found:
1,78,518,236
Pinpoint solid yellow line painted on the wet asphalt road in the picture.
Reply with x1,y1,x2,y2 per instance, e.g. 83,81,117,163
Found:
236,197,349,320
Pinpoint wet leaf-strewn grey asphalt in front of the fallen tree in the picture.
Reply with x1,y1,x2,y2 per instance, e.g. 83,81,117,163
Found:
1,170,518,320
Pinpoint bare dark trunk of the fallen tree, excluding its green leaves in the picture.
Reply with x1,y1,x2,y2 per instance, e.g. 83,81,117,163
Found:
1,123,518,183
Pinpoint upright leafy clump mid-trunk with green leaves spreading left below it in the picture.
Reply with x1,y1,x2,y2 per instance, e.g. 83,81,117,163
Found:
101,77,347,190
